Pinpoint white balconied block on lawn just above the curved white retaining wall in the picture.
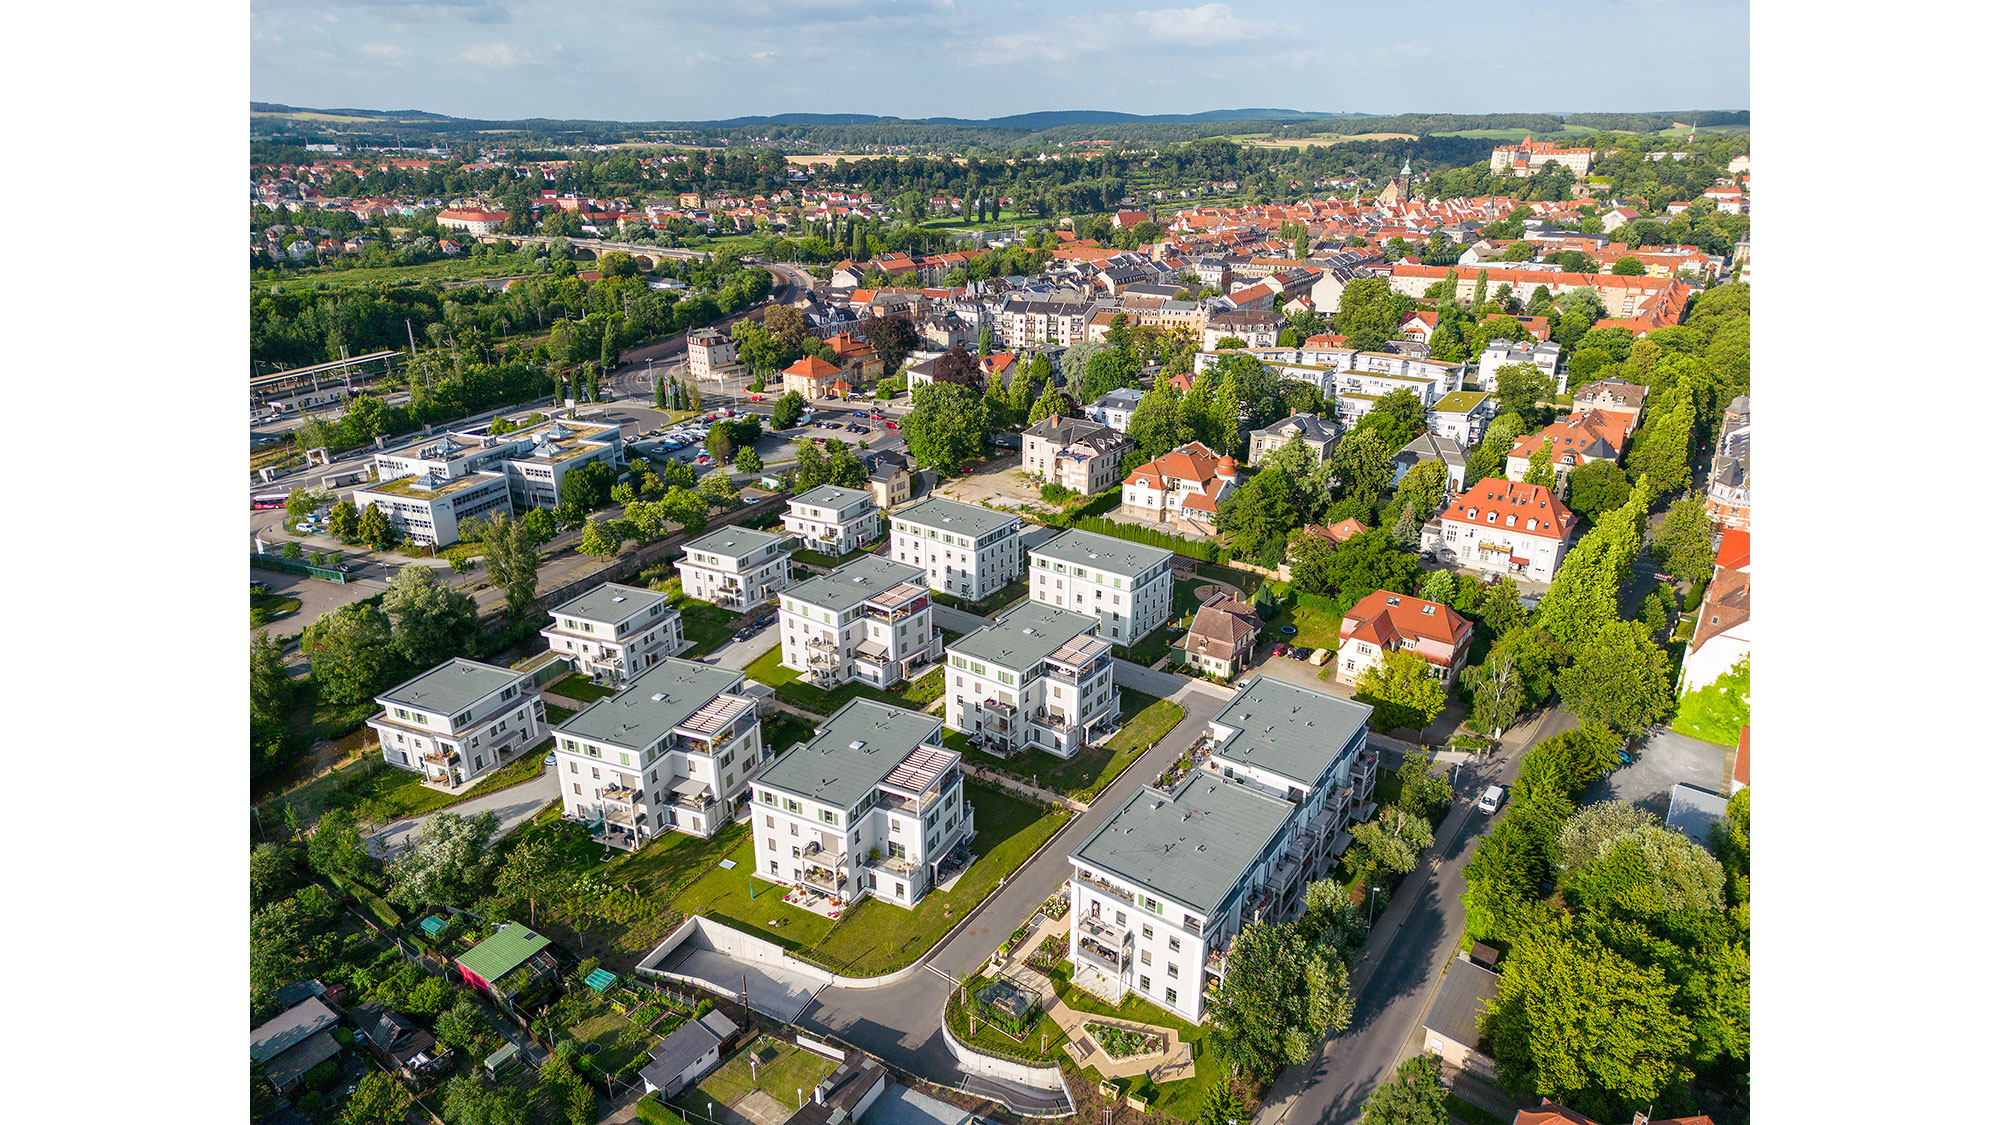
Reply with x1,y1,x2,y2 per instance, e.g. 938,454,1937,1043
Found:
750,699,974,907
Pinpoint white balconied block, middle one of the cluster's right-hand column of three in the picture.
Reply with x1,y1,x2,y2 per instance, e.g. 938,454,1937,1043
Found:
944,601,1120,759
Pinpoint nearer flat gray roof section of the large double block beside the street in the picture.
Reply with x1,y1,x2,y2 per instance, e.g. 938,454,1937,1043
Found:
1070,773,1292,915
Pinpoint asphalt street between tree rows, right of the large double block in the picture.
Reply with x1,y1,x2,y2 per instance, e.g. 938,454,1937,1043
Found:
1256,709,1576,1125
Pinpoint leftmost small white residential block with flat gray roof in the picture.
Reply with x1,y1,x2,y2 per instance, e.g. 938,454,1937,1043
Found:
368,657,548,789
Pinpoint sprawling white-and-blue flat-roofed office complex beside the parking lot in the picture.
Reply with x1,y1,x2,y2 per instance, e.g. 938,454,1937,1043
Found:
352,420,622,546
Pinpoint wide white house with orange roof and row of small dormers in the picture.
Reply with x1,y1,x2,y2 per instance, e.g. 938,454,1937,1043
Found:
1422,476,1576,583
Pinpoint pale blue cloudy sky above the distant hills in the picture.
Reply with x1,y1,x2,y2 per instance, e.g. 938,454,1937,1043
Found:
250,0,1750,120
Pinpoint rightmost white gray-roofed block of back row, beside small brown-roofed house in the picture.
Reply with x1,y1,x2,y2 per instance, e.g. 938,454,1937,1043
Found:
1028,528,1174,645
